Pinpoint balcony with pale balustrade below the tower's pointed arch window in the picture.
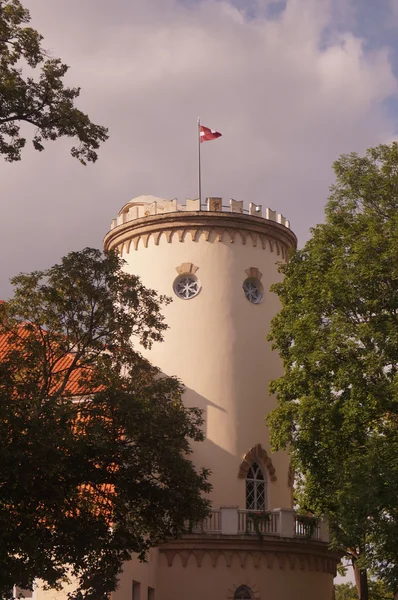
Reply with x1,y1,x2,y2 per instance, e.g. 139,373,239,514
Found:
187,506,329,543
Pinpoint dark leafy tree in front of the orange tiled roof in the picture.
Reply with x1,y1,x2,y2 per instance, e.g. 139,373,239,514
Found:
0,249,209,600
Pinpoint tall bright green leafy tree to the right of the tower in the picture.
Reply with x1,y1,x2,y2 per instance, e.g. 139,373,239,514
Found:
269,143,398,600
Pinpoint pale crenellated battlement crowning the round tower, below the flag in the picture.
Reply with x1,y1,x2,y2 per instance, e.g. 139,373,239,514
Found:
111,196,290,230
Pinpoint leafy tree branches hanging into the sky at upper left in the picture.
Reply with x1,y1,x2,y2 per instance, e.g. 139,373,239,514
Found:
0,0,108,164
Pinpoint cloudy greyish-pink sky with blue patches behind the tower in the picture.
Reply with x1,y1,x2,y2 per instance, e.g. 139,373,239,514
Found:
0,0,398,298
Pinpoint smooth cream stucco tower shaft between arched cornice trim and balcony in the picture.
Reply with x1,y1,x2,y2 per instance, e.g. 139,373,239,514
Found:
119,227,291,508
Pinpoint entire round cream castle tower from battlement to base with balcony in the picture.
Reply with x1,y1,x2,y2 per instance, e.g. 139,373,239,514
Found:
104,196,338,600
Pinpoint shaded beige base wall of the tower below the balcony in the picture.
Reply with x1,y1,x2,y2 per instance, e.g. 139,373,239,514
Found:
111,545,333,600
